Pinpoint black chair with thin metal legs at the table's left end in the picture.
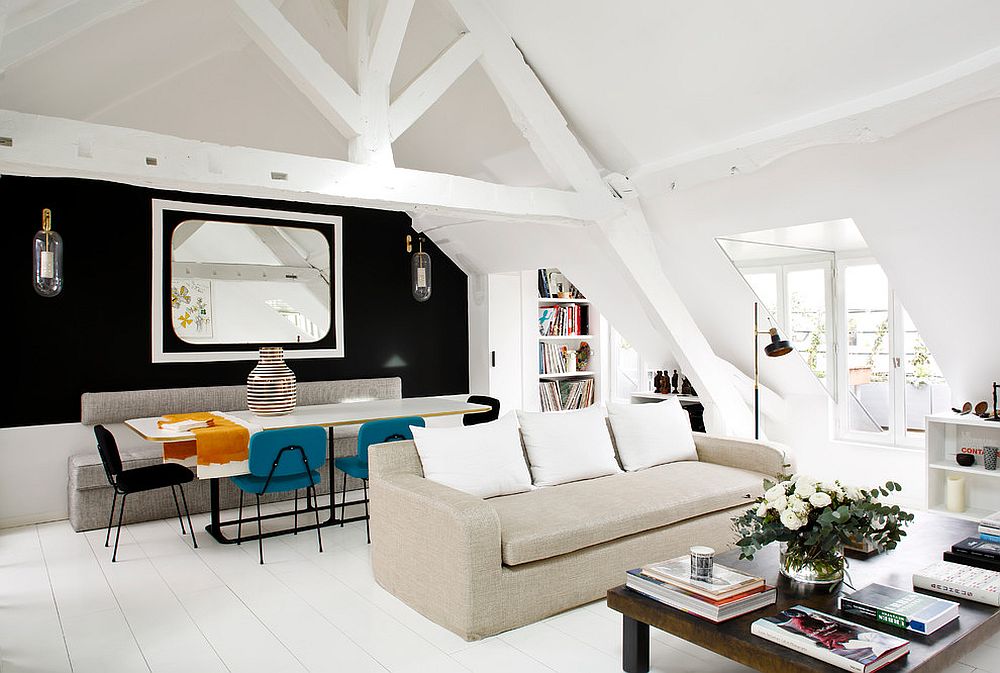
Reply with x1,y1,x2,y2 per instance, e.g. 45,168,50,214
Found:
94,425,198,563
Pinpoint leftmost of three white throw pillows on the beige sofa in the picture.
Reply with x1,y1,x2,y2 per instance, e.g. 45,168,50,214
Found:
410,413,531,498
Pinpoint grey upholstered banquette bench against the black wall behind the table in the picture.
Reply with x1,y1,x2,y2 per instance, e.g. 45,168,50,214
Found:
68,377,402,531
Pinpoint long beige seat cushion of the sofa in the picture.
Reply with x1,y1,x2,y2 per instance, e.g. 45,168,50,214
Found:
487,461,764,566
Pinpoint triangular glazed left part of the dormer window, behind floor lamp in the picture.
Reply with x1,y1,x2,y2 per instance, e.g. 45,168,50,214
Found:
718,232,837,398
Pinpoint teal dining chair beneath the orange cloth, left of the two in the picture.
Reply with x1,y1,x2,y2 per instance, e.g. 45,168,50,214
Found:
230,426,326,564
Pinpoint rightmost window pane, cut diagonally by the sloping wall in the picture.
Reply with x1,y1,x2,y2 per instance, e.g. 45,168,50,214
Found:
902,309,951,436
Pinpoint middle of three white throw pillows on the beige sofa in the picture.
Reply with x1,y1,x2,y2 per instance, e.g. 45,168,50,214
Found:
517,406,621,486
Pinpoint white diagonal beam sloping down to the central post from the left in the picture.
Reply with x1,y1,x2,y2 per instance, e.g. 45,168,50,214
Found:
232,0,362,138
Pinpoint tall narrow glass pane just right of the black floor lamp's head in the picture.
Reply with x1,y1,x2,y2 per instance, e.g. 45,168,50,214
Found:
787,269,827,382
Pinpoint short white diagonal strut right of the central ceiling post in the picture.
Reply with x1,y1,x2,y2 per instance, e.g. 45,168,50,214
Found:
389,33,483,140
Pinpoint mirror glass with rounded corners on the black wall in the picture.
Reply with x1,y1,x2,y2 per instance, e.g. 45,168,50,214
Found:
170,219,331,344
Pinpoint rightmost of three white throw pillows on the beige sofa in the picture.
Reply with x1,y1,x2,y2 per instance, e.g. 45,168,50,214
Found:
608,398,698,472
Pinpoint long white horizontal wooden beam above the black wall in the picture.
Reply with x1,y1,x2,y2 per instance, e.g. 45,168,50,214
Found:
0,110,612,226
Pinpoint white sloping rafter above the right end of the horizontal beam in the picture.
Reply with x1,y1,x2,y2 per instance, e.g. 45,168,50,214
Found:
450,0,607,194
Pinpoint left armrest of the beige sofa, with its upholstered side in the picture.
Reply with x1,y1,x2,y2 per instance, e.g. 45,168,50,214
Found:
369,442,501,639
